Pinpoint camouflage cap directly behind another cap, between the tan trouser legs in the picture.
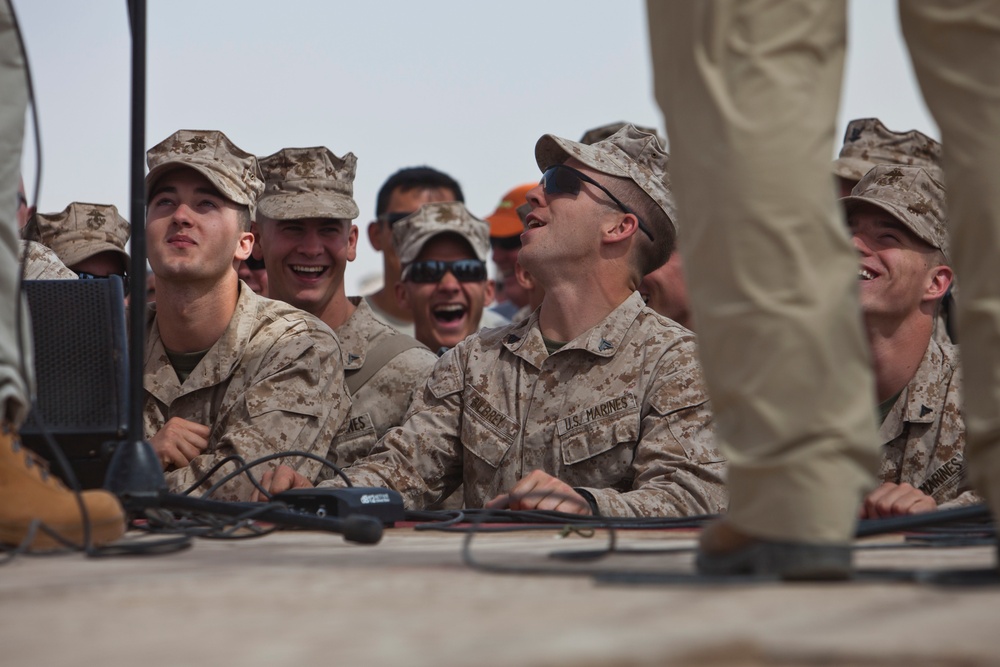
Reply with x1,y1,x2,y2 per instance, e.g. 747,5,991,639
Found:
833,118,941,181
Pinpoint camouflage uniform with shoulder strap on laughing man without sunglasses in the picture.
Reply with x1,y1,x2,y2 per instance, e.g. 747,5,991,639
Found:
328,297,437,470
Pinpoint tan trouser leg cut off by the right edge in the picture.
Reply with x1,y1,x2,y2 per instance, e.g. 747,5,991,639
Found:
899,0,1000,517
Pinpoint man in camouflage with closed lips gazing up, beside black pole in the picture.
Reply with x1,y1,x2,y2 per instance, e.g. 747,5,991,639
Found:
143,130,350,500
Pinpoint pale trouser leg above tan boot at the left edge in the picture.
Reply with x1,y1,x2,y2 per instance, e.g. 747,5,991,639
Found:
0,0,32,424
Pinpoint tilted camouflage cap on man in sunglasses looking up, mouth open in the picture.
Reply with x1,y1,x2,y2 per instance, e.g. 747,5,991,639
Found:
535,125,677,232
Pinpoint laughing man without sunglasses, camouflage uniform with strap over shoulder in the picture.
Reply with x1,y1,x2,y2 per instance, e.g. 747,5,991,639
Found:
255,147,437,470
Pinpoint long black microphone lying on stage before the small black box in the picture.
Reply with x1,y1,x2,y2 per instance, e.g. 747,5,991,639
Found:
122,493,382,544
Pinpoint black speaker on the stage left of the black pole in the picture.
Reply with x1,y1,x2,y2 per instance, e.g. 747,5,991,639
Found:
21,276,128,488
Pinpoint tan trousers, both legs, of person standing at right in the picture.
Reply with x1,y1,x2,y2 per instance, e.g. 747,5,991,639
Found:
647,0,1000,543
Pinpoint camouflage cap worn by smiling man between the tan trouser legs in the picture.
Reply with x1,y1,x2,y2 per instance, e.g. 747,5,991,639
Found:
840,164,950,259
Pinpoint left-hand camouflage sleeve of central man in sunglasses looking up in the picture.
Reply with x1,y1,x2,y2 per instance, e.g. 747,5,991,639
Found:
321,348,465,509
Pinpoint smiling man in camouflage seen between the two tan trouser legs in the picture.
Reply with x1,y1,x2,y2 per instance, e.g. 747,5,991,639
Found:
841,165,981,517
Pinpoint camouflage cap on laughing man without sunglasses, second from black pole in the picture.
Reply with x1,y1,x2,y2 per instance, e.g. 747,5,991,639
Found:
257,146,358,220
